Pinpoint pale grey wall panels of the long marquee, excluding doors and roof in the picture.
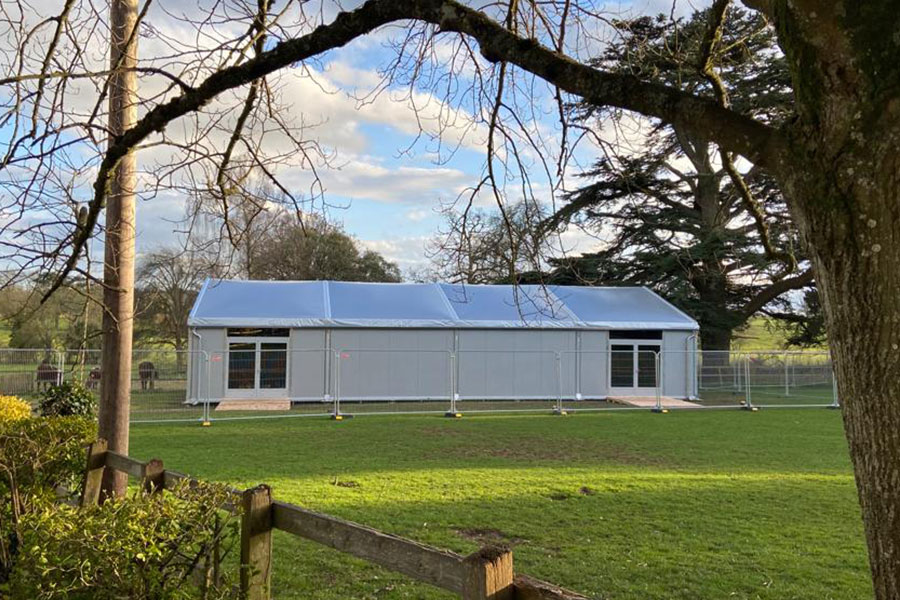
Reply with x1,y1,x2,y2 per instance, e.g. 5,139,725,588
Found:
188,328,696,401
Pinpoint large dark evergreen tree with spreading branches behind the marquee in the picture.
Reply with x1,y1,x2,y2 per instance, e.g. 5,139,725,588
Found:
551,8,812,350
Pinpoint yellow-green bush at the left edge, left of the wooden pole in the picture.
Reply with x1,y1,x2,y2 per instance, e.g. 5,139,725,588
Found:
0,417,97,582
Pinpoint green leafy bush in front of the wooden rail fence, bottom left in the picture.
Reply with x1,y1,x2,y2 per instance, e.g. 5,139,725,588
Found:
11,481,239,600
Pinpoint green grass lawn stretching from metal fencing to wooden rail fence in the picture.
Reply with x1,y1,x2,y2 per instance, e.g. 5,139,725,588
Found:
131,409,871,600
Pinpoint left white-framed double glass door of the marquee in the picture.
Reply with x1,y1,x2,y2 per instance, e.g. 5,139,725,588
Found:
226,338,287,398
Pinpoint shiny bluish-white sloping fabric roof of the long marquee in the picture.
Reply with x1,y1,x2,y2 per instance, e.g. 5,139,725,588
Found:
188,279,698,331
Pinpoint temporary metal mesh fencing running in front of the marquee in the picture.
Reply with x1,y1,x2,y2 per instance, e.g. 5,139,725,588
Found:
0,346,839,423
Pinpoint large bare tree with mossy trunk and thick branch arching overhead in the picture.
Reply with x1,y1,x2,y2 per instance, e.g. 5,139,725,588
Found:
0,0,900,599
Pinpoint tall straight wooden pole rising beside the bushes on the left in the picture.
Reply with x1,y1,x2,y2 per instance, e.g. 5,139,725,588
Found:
100,0,138,496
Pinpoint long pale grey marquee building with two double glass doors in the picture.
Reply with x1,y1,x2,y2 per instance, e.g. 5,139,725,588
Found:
187,279,698,403
